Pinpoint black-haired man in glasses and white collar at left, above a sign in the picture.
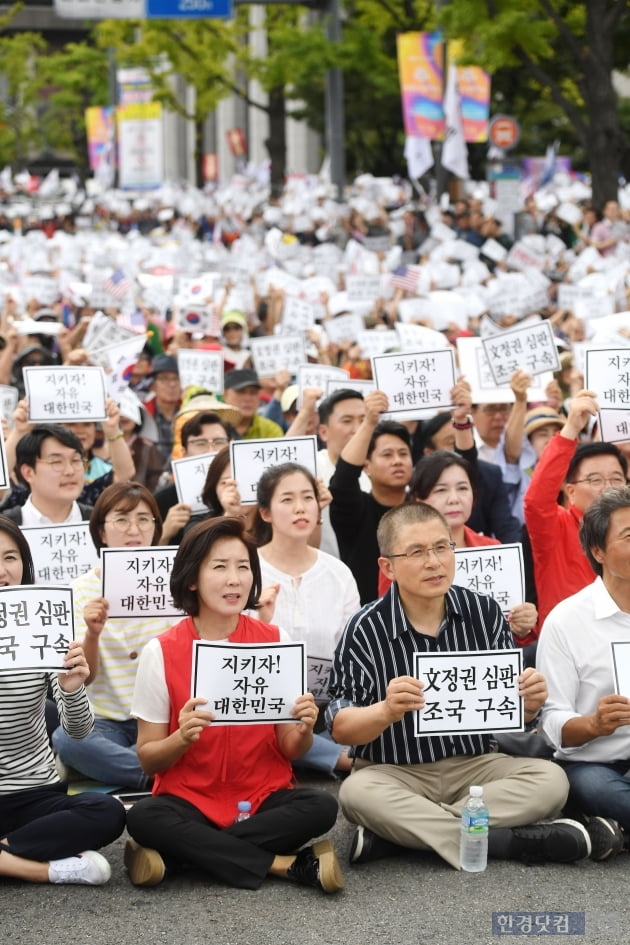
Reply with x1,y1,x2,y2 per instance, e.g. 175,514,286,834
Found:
5,424,91,528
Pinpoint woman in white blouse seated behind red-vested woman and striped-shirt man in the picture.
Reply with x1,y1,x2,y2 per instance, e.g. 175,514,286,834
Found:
256,463,359,774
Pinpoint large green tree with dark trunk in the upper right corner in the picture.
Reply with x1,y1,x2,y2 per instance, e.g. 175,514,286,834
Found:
442,0,630,206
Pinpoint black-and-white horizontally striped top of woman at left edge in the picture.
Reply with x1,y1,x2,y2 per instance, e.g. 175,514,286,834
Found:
0,673,94,796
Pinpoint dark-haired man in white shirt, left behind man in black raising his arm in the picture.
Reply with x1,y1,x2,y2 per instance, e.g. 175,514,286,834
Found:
317,388,372,558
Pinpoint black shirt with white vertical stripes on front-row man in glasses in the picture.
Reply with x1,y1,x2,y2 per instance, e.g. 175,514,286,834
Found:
326,584,514,765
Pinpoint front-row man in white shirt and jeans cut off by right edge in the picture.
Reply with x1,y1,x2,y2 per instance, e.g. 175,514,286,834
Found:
536,487,630,845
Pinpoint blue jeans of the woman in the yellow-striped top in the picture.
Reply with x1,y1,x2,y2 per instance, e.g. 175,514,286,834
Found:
52,716,148,791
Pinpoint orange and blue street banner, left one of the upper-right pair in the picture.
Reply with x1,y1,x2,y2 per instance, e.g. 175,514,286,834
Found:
396,33,445,139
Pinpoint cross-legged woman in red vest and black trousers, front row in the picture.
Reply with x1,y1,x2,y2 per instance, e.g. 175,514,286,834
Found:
125,517,344,893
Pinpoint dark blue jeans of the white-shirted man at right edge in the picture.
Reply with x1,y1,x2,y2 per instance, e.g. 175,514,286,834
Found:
561,761,630,832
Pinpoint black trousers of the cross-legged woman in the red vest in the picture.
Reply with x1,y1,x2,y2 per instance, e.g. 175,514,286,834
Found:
127,788,337,889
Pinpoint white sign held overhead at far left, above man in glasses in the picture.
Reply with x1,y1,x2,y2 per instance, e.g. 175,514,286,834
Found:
22,365,107,423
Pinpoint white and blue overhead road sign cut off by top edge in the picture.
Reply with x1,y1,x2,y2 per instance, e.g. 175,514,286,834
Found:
54,0,232,20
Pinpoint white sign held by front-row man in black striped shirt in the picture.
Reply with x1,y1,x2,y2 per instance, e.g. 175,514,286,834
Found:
414,649,525,737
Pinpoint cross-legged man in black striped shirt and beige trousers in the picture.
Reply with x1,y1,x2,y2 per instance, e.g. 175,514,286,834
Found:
326,502,620,869
